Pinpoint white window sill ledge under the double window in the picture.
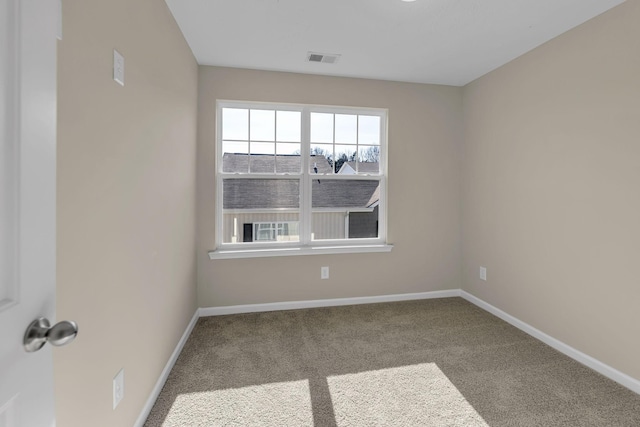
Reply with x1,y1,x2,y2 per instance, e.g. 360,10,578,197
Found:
209,244,393,259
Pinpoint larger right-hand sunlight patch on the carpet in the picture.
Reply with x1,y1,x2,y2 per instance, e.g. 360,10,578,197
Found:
327,363,488,427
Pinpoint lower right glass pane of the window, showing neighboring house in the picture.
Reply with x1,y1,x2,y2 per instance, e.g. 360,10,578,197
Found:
311,179,380,240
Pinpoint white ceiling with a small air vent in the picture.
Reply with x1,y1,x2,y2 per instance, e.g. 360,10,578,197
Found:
166,0,624,86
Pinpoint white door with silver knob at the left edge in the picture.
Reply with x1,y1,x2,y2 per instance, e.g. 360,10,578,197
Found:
0,0,59,427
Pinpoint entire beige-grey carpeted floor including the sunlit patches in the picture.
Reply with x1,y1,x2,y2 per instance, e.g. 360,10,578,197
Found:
145,298,640,427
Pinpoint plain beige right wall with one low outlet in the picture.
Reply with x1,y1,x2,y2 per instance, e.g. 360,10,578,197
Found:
462,0,640,378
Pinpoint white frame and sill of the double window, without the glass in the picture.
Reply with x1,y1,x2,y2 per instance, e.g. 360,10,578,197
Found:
209,100,393,259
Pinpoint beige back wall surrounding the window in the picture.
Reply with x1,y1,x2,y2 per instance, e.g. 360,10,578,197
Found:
197,66,462,307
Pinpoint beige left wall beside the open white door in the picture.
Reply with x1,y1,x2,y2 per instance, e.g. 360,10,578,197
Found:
54,0,197,427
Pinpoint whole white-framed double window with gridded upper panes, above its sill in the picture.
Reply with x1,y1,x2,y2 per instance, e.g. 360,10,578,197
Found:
216,101,386,258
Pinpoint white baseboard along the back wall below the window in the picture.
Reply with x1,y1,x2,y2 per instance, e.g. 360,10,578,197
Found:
200,289,460,317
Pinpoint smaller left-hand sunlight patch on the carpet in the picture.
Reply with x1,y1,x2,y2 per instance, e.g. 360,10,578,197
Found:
163,380,313,427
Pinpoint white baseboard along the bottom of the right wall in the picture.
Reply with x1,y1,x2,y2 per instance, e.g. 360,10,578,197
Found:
460,290,640,394
